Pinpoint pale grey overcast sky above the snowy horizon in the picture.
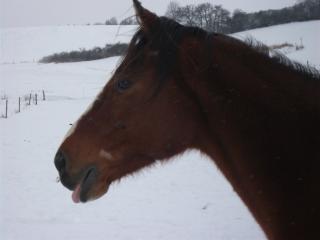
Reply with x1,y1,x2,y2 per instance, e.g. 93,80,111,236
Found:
0,0,296,27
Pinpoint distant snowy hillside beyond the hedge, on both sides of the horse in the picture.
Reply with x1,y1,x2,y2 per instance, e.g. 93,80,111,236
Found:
0,21,320,66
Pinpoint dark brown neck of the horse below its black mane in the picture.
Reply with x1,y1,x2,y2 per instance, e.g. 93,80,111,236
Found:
181,34,320,239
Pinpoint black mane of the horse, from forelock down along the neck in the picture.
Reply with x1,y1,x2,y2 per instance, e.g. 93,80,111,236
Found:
120,17,320,86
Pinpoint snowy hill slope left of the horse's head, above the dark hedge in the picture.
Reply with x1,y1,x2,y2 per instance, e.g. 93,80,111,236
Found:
0,25,137,63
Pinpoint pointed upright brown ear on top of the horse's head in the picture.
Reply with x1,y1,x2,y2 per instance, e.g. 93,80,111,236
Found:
133,0,159,32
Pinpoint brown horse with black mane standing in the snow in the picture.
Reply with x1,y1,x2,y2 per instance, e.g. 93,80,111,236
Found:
55,0,320,240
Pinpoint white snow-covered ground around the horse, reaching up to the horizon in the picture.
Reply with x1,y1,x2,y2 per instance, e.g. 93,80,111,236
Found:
0,21,320,240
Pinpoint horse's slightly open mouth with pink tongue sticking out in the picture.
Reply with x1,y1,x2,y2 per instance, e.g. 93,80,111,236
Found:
72,167,98,203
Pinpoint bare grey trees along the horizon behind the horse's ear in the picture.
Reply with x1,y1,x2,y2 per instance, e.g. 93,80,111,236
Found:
105,0,320,34
